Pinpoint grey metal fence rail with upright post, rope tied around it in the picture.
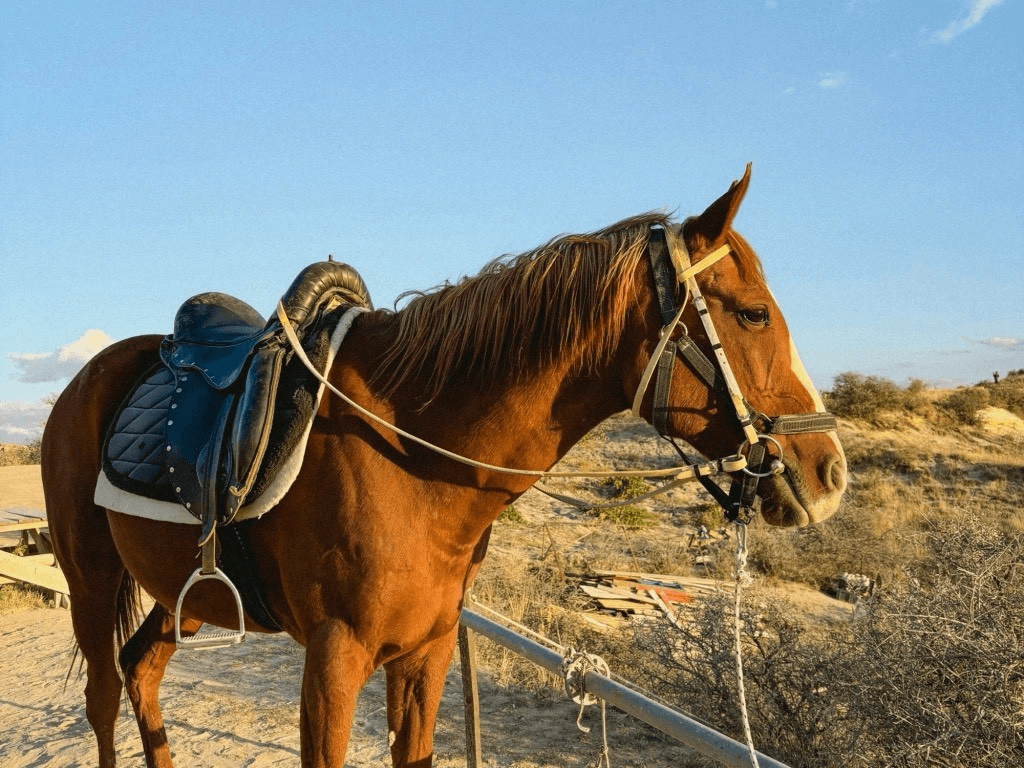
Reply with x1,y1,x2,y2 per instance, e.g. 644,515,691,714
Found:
459,608,788,768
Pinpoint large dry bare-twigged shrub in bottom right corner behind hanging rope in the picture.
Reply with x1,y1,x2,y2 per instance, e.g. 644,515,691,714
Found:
631,513,1024,768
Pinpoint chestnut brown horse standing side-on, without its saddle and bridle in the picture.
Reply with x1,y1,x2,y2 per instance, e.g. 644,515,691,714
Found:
42,168,846,768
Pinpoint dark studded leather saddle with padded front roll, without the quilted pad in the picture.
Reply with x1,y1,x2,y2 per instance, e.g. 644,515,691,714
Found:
152,261,372,542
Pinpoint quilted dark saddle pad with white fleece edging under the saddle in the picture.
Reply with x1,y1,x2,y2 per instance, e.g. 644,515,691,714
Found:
93,307,367,525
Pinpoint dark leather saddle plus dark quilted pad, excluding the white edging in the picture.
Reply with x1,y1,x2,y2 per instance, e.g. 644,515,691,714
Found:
103,261,372,544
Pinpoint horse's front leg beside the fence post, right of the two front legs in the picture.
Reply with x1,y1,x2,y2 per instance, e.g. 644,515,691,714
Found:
384,625,459,768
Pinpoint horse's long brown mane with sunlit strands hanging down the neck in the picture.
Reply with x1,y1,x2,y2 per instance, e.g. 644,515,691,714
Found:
375,213,672,407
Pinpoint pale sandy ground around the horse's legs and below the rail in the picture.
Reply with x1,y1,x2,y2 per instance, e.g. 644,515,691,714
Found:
0,608,704,768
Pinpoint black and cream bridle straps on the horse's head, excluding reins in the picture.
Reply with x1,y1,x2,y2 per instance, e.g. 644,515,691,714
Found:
633,222,837,521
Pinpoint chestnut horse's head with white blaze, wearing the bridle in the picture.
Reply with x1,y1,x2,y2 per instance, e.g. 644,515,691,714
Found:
635,166,846,525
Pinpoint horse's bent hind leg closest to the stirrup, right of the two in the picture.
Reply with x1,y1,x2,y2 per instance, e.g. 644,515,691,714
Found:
121,603,203,768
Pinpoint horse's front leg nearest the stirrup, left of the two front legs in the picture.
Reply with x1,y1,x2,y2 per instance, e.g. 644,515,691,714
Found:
299,622,373,768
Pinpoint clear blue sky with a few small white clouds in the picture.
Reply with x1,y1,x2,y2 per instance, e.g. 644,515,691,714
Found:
0,0,1024,442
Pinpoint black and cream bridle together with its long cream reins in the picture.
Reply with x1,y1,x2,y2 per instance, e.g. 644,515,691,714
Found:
276,222,837,522
